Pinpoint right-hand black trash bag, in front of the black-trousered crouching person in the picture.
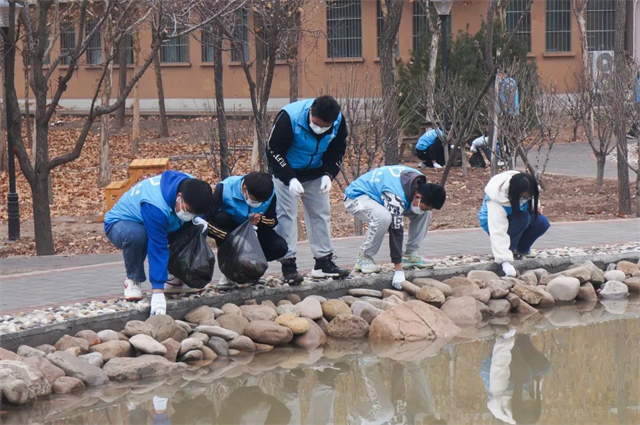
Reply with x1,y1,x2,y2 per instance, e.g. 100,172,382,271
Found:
218,220,269,283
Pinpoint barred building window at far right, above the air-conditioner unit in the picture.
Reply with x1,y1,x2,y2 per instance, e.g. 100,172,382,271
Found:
587,0,616,50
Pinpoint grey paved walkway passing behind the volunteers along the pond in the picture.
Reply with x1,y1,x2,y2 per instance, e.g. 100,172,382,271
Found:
0,219,640,314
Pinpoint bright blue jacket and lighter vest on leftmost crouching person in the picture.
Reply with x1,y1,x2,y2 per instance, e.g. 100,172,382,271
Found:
104,171,193,289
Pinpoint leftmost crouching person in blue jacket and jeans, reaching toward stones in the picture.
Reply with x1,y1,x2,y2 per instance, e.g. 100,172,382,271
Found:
104,171,211,315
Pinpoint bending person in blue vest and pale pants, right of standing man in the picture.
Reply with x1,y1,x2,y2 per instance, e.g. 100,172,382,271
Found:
344,165,446,290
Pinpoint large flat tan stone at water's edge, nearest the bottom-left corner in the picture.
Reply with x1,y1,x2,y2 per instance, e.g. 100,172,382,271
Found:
103,354,187,381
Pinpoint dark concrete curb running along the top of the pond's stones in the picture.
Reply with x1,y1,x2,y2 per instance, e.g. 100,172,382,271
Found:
0,251,640,351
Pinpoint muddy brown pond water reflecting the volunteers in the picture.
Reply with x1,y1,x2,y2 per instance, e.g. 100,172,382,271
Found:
0,301,640,425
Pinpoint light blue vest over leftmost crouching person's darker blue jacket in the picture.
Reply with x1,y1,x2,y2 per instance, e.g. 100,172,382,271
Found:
104,175,185,233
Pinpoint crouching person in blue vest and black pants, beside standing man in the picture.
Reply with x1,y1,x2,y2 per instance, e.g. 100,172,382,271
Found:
205,172,287,291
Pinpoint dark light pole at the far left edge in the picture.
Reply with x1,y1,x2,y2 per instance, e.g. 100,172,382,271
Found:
0,0,22,241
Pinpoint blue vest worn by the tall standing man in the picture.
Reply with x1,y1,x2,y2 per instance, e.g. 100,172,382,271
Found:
282,99,342,170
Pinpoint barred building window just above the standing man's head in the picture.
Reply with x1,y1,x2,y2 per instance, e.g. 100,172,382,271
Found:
327,0,362,58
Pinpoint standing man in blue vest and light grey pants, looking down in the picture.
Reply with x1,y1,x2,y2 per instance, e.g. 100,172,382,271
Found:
267,95,349,285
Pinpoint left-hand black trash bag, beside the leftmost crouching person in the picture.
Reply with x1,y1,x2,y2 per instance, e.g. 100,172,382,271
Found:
167,223,216,289
